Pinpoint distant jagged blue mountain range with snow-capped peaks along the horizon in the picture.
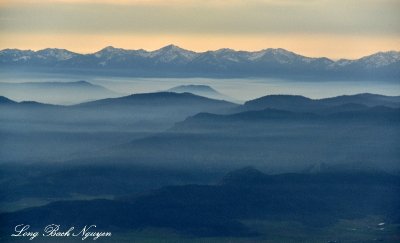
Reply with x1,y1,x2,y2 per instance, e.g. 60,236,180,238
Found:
0,45,400,81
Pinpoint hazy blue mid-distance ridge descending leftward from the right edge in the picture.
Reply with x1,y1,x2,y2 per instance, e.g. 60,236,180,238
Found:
86,99,400,173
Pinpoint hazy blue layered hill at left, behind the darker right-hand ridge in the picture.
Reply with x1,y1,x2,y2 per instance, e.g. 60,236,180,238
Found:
0,92,237,162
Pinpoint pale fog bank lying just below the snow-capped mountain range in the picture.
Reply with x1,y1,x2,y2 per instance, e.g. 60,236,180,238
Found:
0,72,400,104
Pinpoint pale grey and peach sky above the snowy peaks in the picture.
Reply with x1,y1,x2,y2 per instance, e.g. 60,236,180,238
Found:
0,0,400,59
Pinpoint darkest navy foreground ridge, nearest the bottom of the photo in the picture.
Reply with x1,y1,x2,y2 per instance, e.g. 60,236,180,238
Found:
0,167,400,236
